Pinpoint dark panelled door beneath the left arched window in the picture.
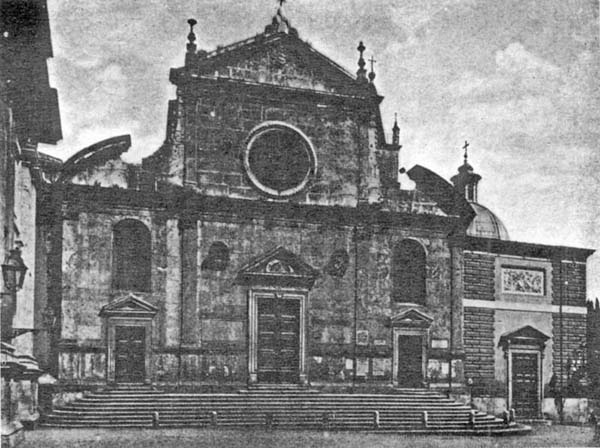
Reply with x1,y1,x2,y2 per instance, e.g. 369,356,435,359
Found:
115,326,146,383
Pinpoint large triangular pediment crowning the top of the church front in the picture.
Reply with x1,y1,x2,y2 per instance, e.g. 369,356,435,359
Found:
192,33,360,94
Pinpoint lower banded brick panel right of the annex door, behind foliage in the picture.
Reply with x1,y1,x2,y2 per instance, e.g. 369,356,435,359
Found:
552,313,587,385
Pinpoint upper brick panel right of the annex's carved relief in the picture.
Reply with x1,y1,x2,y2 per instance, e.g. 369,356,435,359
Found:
552,260,586,306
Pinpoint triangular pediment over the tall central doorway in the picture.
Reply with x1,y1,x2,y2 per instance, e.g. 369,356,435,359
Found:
236,246,319,289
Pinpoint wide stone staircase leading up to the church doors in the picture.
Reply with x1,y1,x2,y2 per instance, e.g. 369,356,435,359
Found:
42,387,531,435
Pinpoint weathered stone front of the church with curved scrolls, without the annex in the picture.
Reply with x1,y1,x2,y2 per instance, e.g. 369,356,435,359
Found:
38,12,472,389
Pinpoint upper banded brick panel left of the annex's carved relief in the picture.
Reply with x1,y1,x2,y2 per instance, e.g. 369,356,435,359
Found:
464,252,495,300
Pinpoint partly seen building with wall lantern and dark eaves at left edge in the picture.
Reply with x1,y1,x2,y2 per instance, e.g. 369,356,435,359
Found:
0,0,62,446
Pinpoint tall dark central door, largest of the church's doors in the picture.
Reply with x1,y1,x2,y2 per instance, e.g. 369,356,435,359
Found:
257,297,300,383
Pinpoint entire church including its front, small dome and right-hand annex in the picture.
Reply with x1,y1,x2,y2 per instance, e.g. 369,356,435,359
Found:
34,10,592,415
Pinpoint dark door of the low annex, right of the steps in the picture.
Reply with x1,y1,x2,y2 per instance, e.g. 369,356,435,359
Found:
512,352,540,418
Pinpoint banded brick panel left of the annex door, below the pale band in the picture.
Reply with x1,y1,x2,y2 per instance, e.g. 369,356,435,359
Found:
464,307,494,386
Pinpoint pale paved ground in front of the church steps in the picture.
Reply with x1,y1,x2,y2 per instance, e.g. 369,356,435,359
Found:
20,426,597,448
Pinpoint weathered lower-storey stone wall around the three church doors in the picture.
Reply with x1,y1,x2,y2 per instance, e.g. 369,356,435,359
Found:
48,182,460,384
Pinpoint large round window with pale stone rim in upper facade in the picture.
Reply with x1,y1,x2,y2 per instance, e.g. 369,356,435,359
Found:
244,122,316,197
